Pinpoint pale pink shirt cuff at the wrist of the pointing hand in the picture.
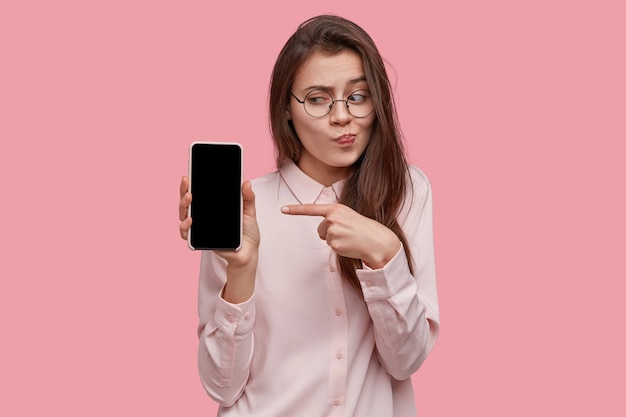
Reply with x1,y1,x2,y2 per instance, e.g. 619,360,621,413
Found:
356,246,412,300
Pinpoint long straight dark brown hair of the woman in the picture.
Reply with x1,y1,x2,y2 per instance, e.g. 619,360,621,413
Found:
270,15,413,291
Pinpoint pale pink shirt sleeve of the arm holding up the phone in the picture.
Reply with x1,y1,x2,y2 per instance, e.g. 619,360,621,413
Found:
198,251,255,407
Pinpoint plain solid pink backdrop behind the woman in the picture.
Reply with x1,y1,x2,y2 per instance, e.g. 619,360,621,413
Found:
0,0,626,417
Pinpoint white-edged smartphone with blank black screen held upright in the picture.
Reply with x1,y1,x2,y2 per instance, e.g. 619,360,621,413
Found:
187,142,243,250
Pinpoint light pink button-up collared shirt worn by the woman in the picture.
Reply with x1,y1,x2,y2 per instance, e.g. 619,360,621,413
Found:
198,161,439,417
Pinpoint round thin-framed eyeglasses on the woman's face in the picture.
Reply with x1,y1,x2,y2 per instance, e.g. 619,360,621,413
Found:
291,90,374,119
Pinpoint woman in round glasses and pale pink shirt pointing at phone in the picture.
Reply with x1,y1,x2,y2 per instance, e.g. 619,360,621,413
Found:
179,16,439,417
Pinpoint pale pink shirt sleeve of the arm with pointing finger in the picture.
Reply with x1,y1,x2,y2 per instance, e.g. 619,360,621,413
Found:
357,167,439,380
